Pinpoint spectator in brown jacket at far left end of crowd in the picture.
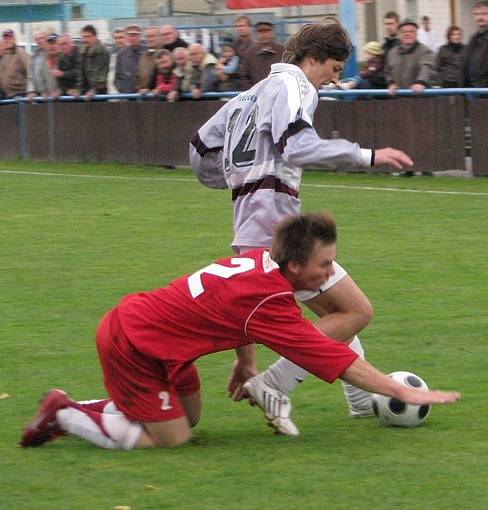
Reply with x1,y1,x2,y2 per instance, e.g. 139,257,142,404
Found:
0,28,28,98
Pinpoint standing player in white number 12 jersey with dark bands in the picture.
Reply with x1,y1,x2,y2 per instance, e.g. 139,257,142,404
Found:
190,22,413,435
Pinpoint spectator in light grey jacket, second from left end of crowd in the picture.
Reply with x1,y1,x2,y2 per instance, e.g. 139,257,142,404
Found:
28,32,57,99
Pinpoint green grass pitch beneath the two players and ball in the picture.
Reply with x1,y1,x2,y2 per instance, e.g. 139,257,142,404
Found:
0,161,488,510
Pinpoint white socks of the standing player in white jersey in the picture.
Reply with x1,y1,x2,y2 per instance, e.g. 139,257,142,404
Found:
264,336,372,416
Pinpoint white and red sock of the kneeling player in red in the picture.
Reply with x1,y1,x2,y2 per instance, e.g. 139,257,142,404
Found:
56,403,143,450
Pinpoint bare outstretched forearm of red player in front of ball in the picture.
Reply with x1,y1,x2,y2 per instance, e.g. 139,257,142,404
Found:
341,358,461,405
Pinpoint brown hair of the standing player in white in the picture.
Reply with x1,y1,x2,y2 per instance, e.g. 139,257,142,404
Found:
283,18,352,64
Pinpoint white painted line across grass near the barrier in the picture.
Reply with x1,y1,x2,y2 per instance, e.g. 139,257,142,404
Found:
0,170,488,196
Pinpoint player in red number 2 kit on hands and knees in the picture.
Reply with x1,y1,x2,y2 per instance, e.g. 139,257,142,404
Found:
20,213,459,449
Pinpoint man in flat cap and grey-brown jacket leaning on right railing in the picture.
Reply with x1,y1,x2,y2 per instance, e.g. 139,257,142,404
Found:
385,19,435,95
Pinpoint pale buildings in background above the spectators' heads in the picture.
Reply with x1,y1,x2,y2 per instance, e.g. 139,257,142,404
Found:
0,0,476,59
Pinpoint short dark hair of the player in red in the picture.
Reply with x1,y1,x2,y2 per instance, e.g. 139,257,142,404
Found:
271,213,337,270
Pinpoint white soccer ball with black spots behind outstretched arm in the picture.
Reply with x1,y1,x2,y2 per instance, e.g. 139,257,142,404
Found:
373,372,430,427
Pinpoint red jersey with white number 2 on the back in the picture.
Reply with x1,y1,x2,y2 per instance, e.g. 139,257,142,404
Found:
118,249,357,382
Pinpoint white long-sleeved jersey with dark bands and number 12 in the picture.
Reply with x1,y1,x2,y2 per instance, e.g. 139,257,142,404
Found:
190,64,372,247
